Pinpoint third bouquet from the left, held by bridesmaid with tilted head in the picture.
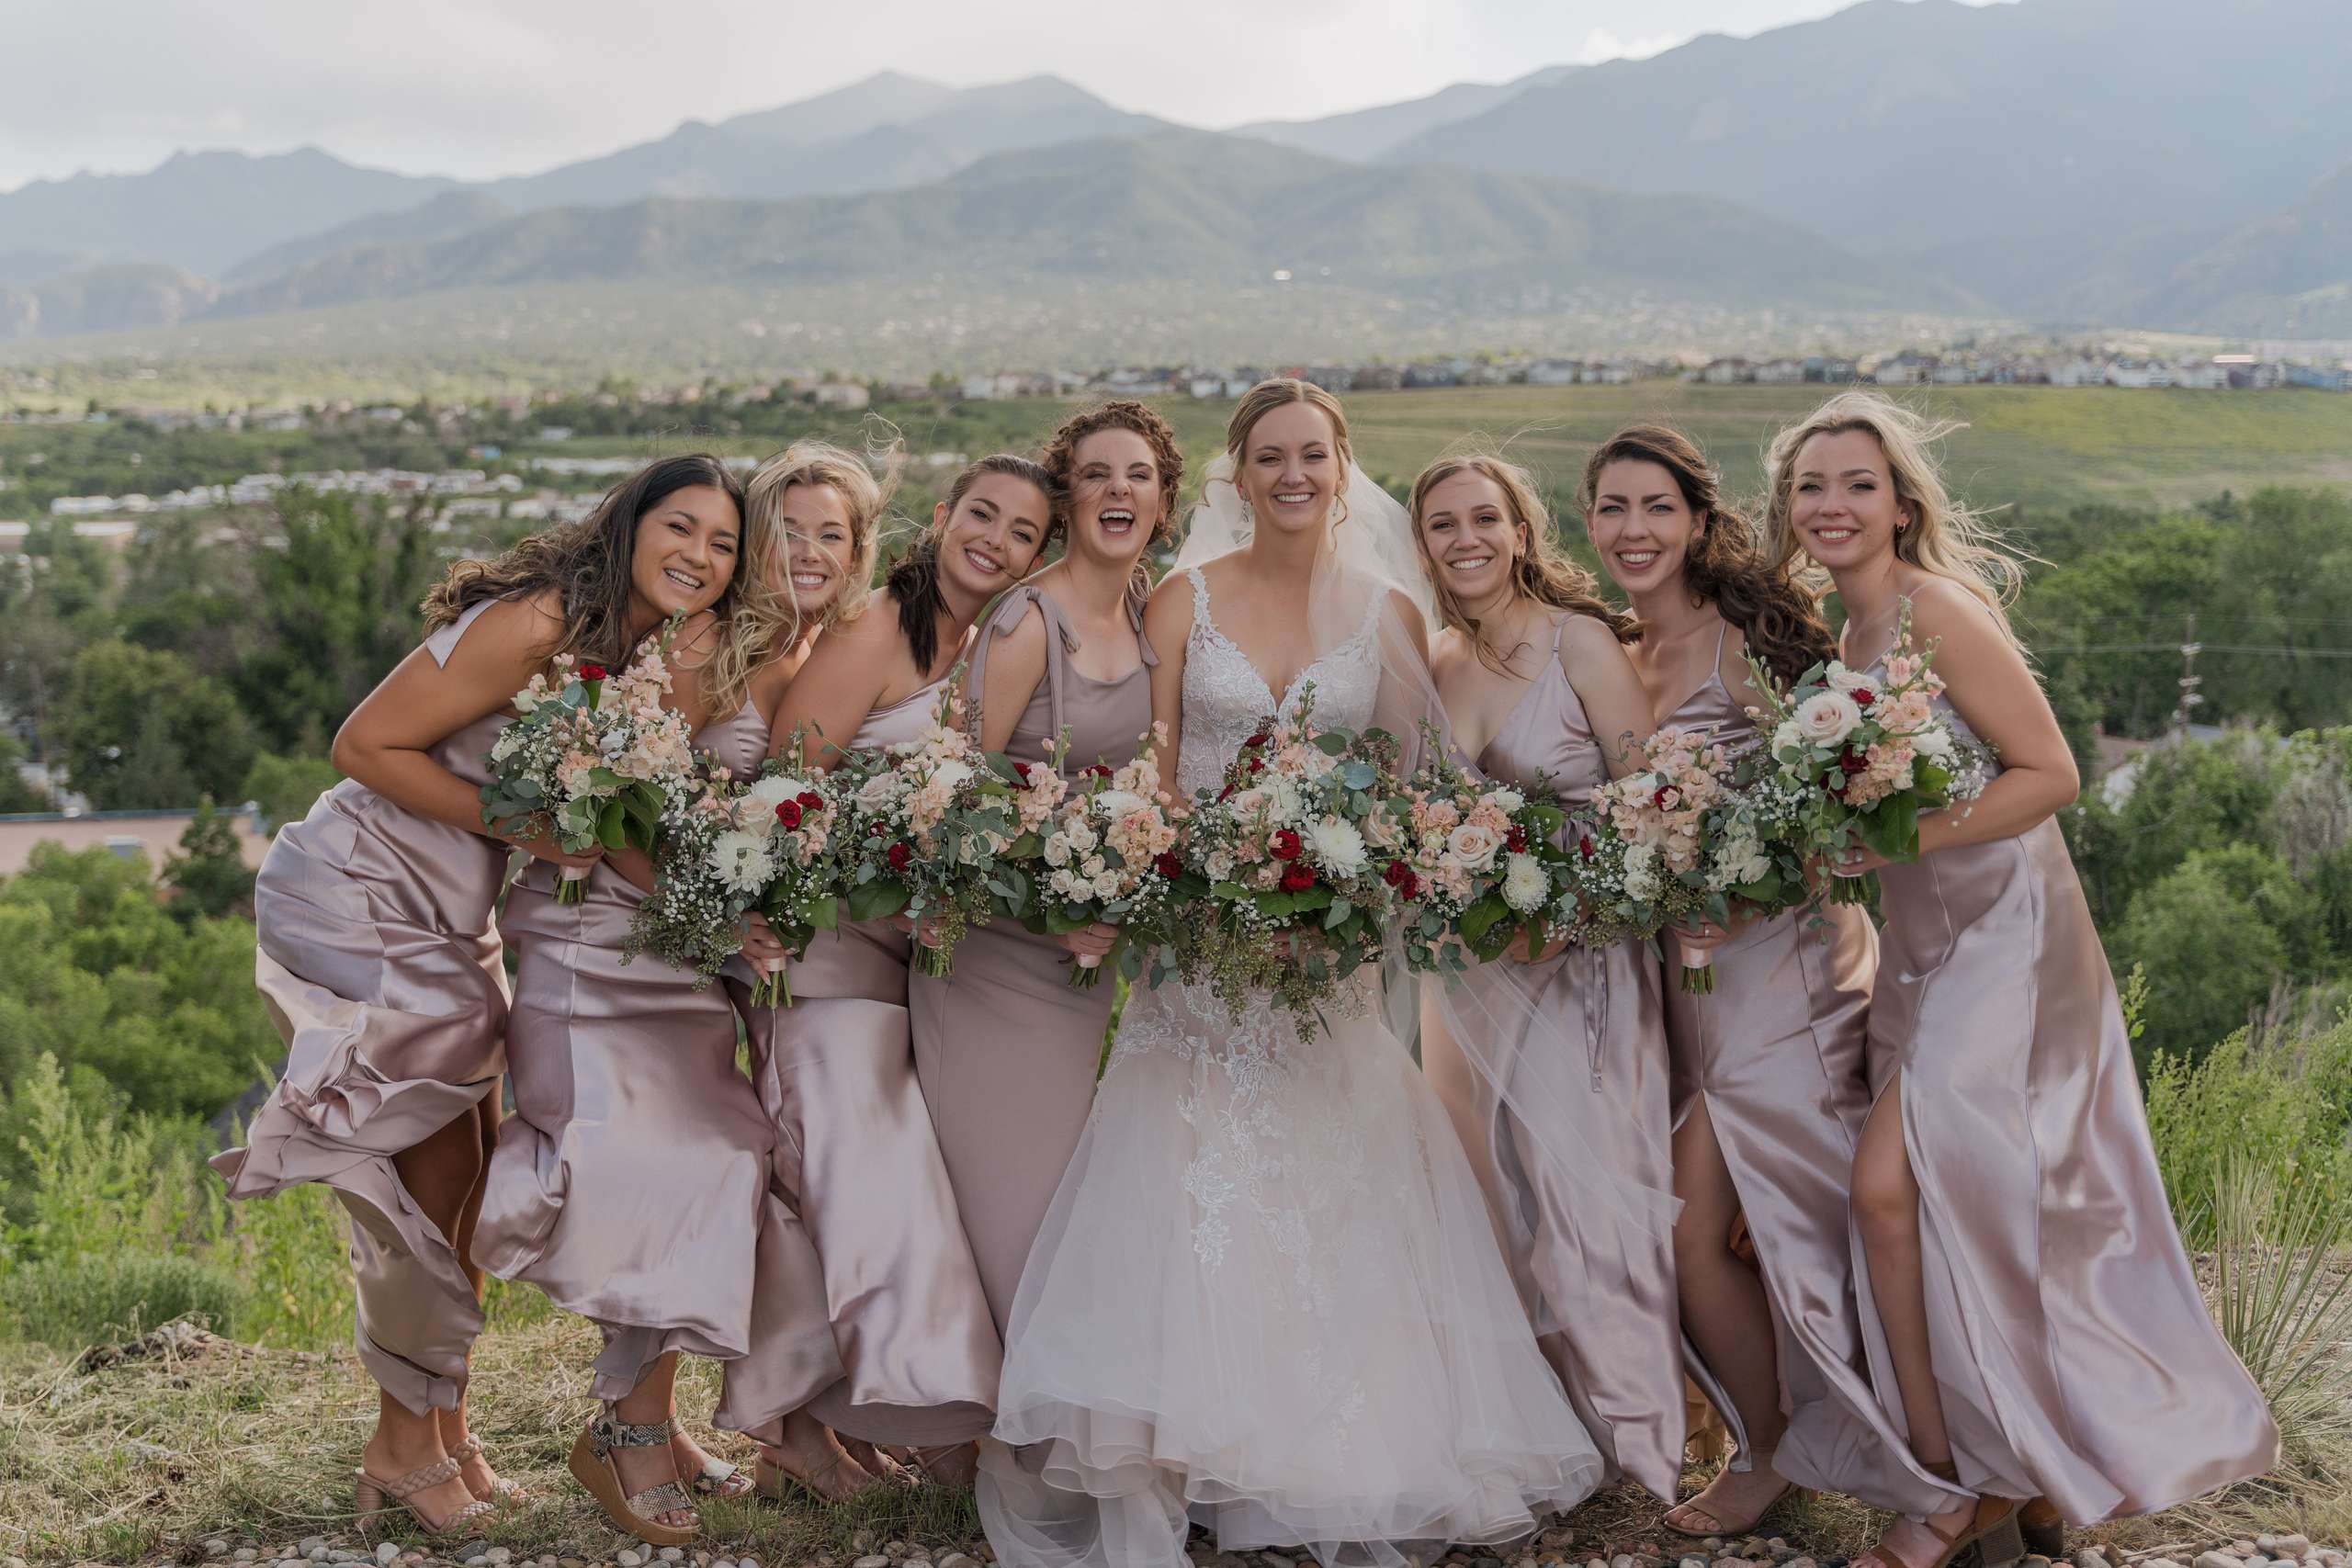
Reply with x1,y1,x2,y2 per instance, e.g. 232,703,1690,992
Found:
832,680,1025,978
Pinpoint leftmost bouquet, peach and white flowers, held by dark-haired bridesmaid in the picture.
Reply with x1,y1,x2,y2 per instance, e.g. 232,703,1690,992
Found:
482,632,694,903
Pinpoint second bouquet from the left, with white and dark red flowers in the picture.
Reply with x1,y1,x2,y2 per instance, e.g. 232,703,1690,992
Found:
621,752,840,1006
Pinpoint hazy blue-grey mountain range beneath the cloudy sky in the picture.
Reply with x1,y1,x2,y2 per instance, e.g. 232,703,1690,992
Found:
14,0,2352,350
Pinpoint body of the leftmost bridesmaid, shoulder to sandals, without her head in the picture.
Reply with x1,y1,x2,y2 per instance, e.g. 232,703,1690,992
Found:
211,495,628,1535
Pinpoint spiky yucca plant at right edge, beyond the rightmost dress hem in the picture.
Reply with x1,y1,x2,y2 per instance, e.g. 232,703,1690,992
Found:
2211,1156,2352,1485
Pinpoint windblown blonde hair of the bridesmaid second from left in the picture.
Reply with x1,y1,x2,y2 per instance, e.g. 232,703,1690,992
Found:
738,440,903,703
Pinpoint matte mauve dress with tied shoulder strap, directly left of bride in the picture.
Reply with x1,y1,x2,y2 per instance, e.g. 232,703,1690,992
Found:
908,588,1158,1333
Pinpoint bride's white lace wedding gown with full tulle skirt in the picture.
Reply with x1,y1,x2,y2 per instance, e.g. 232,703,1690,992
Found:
981,571,1601,1568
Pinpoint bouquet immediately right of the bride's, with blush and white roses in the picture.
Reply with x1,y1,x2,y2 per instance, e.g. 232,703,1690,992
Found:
1387,733,1569,980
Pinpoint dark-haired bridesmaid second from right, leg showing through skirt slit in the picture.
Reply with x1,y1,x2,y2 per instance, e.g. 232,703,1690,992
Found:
1578,425,1905,1535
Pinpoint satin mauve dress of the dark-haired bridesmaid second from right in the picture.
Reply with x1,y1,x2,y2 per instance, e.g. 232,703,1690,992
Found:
1658,644,1957,1514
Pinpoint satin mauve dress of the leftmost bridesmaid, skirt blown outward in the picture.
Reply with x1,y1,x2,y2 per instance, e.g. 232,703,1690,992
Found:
211,600,511,1416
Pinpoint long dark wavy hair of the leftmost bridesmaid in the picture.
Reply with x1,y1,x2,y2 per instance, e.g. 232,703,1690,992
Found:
424,451,755,677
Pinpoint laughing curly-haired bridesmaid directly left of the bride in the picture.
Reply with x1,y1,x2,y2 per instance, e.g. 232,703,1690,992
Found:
908,402,1183,1336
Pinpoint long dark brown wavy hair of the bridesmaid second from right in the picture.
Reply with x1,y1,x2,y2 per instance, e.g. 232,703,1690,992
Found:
1576,425,1837,684
